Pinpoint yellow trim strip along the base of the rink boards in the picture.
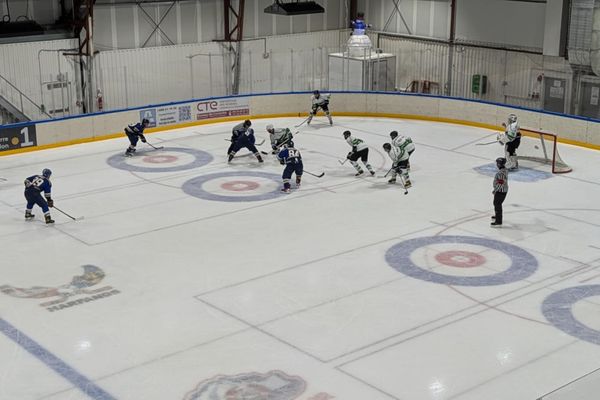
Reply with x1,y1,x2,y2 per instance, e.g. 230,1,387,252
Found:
0,112,600,156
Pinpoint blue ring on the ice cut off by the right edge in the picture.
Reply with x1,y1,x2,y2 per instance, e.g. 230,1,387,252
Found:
542,285,600,345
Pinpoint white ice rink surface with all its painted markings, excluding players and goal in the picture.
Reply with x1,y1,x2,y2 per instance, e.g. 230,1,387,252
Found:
0,117,600,400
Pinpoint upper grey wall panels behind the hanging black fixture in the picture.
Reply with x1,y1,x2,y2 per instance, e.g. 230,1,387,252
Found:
94,0,348,50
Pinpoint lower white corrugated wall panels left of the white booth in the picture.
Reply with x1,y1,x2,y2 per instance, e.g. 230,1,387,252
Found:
95,30,347,110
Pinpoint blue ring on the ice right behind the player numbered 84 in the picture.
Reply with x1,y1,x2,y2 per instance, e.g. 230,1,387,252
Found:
182,171,285,202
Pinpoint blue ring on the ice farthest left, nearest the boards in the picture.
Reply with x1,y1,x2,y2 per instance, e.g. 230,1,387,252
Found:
106,147,213,172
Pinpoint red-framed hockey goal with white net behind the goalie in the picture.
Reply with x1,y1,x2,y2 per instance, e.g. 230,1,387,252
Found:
517,128,573,174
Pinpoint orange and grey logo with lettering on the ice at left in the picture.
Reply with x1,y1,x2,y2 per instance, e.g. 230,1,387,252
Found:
0,265,121,312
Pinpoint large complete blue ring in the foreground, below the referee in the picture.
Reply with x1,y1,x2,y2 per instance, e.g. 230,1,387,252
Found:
385,236,538,286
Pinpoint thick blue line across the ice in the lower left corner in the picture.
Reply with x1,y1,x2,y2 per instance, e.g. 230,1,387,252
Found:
0,318,116,400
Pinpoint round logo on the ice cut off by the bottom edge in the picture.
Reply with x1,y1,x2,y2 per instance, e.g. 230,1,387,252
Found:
184,371,306,400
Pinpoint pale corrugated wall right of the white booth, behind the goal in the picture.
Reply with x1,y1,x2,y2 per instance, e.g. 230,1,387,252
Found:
379,35,572,108
